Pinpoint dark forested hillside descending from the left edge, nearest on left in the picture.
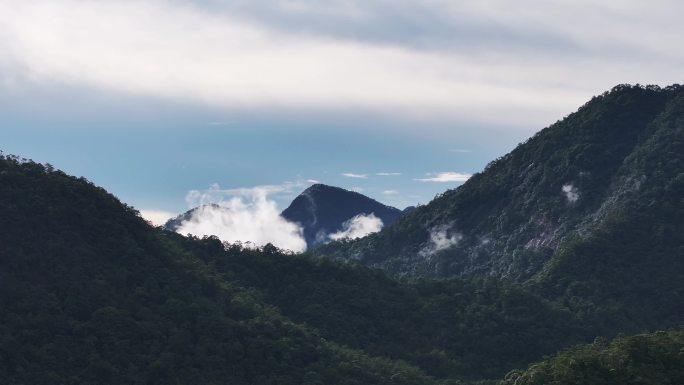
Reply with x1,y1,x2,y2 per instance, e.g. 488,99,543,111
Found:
0,157,432,385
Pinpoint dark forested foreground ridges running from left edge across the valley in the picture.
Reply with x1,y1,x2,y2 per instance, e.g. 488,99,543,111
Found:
0,113,681,385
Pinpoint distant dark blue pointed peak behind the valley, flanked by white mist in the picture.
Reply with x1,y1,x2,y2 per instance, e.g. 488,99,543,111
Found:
281,184,403,247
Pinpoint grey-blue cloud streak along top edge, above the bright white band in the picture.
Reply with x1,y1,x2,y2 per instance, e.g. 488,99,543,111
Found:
179,0,684,61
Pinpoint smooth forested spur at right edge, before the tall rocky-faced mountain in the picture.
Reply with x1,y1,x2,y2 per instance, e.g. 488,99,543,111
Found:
538,90,684,330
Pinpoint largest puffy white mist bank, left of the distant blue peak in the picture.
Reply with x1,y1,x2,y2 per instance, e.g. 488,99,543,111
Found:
176,184,306,252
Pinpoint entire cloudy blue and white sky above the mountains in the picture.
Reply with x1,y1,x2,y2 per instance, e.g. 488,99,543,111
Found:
0,0,684,228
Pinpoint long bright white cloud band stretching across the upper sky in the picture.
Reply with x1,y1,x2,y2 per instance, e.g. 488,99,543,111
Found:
0,0,660,126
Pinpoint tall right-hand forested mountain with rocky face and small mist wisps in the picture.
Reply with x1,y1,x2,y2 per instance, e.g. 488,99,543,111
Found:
312,85,684,281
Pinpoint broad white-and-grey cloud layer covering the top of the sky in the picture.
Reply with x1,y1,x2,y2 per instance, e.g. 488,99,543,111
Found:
5,0,684,124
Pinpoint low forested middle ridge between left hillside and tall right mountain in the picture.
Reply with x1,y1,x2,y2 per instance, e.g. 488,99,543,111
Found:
179,237,584,379
